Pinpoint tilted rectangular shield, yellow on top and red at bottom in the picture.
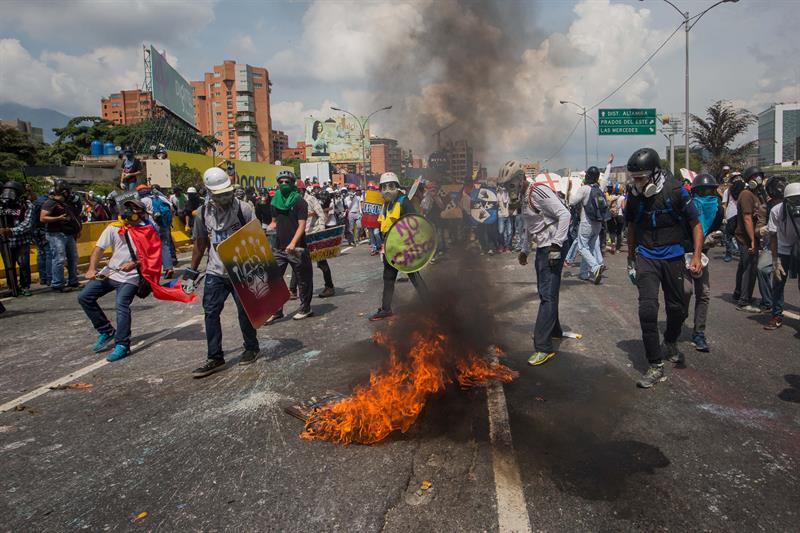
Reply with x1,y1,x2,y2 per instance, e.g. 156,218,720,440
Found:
217,219,289,328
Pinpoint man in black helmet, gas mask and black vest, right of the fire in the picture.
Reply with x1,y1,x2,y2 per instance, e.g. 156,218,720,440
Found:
625,148,703,388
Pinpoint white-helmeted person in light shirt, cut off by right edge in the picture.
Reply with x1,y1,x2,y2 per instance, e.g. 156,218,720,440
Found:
764,183,800,330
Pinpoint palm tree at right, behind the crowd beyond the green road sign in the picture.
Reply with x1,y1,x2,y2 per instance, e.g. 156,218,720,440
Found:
690,100,758,180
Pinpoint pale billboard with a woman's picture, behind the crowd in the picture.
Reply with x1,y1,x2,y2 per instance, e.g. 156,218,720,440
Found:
305,115,369,163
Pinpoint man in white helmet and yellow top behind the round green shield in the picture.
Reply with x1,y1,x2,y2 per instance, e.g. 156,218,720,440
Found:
369,172,428,321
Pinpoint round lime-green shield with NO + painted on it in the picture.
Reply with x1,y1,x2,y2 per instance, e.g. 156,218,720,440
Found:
383,215,436,273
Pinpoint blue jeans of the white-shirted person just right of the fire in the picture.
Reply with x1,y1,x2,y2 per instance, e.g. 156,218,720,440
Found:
533,246,564,352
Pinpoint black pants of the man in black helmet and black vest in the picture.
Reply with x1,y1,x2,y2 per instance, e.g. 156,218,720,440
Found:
636,255,688,365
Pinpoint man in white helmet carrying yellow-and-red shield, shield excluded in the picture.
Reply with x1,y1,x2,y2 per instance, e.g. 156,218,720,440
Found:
182,167,259,378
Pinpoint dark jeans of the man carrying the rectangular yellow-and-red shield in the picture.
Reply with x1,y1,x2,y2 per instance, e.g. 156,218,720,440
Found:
203,274,259,361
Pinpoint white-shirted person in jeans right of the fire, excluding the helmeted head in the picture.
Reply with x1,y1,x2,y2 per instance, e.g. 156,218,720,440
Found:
518,177,570,366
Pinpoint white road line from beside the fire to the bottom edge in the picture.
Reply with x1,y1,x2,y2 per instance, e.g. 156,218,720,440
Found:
486,382,531,533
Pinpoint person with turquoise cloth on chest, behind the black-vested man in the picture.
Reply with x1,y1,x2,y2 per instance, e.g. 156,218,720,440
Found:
684,174,725,352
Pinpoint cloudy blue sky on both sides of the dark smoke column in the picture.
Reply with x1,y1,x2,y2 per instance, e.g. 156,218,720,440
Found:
0,0,800,173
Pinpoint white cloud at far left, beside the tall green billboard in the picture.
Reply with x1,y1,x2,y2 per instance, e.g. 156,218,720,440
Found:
0,39,142,115
